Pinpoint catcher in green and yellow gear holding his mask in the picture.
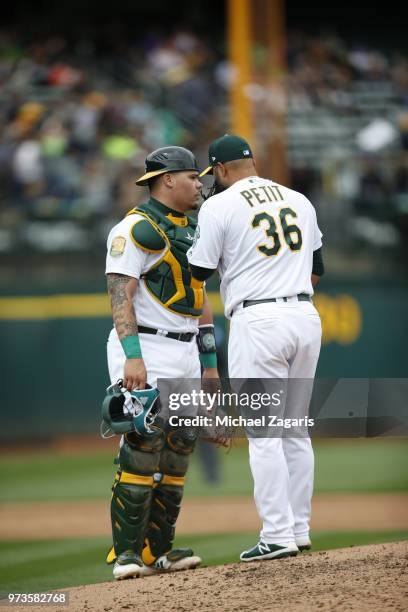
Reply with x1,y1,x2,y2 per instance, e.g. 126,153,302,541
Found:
104,146,222,580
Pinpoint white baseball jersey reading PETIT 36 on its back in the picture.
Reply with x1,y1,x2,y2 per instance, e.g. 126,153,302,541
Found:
187,176,322,318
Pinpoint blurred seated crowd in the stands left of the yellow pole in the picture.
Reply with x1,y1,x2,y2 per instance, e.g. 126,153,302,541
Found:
0,31,225,250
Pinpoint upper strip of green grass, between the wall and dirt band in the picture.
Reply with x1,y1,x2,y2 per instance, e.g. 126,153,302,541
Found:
0,439,408,502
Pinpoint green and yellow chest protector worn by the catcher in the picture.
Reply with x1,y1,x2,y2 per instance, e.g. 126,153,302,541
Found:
130,200,204,317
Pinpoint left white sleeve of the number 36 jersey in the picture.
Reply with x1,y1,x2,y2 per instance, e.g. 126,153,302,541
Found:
187,205,223,270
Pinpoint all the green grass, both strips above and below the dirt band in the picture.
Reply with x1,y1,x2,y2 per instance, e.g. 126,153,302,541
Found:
0,439,408,594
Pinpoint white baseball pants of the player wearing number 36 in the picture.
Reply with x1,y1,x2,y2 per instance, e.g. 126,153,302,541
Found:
228,297,321,544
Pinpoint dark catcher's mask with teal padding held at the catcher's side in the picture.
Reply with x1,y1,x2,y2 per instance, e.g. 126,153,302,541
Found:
101,380,161,438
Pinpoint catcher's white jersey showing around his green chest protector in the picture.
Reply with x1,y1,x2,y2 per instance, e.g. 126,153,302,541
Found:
105,214,198,332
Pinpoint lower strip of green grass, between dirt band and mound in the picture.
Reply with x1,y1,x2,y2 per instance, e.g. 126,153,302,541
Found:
0,531,408,597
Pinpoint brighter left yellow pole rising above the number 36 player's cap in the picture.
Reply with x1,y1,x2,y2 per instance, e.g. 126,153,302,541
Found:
227,0,252,142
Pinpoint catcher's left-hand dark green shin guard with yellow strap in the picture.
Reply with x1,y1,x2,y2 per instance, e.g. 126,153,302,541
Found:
107,429,164,563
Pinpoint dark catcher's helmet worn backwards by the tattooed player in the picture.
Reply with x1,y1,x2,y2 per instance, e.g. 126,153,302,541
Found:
136,147,199,185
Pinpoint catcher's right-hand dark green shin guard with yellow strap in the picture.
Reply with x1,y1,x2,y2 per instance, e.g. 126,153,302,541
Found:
142,429,197,565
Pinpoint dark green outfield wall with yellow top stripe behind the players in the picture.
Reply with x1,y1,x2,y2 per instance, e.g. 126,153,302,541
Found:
0,281,408,442
